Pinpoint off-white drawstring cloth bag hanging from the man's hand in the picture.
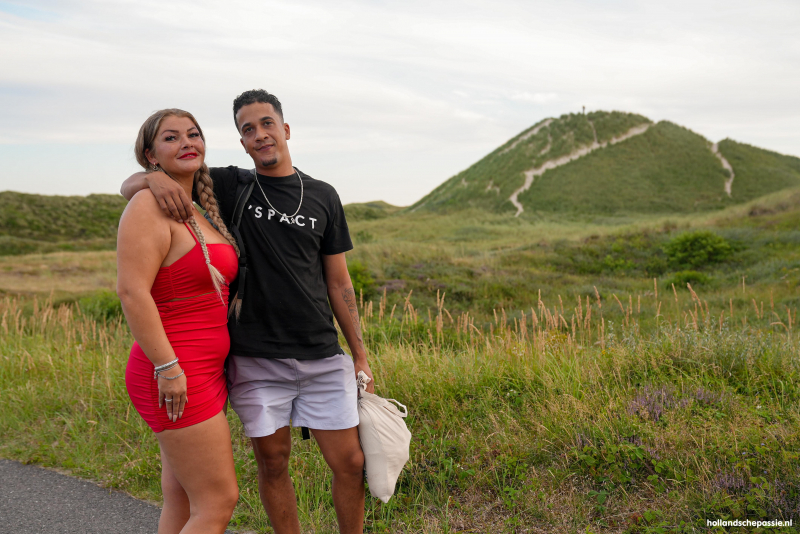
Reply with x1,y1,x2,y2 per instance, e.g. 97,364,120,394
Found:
357,371,411,503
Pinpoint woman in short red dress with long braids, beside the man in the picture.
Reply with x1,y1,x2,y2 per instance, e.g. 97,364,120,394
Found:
117,109,239,534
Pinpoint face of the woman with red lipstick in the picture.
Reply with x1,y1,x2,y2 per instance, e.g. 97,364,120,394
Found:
145,116,206,176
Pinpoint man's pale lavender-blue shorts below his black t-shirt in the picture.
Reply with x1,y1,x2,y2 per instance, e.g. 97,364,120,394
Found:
228,354,358,438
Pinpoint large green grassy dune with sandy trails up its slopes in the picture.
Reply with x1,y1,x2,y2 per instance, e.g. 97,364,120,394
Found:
409,111,800,217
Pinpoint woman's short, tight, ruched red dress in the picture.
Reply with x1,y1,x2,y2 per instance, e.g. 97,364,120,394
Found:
125,225,239,432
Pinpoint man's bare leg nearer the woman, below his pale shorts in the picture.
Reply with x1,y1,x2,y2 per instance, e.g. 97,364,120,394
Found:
251,426,300,534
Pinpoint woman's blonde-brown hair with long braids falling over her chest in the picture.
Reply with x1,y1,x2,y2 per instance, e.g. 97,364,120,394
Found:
134,108,239,317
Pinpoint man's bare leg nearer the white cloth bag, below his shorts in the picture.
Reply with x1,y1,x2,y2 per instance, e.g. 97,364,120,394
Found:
312,427,364,534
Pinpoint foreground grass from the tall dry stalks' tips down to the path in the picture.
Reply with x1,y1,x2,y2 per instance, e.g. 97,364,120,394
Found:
0,284,800,532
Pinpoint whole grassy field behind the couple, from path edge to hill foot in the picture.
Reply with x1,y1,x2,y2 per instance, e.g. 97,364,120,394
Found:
0,191,800,533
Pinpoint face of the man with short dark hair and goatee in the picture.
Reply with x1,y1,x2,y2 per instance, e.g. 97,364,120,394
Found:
236,102,289,169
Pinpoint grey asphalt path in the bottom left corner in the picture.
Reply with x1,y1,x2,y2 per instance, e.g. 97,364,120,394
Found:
0,460,238,534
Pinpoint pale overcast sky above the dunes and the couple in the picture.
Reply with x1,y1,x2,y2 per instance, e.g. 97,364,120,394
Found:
0,0,800,205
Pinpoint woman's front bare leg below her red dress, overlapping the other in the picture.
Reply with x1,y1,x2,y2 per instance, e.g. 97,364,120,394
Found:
158,411,239,534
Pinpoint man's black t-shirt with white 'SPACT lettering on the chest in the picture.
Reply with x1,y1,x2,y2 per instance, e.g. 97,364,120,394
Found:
211,167,353,360
